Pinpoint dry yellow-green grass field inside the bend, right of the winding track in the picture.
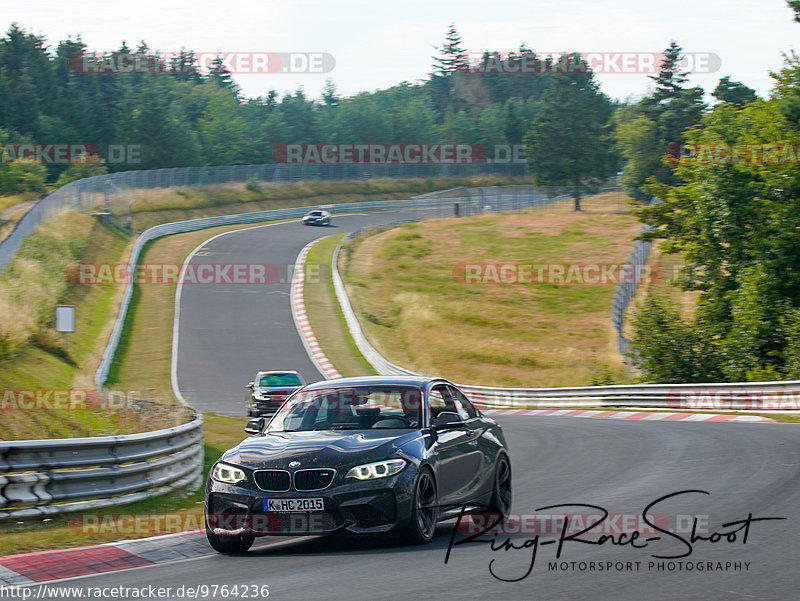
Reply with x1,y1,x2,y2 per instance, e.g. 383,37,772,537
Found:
343,193,640,387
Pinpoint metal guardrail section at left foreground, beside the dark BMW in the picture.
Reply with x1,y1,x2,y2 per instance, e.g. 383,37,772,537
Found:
0,413,203,521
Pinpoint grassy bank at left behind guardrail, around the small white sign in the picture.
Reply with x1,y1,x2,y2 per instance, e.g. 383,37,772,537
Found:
0,213,164,440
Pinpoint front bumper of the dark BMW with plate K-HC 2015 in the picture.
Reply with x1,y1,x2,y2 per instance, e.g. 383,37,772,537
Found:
206,465,416,536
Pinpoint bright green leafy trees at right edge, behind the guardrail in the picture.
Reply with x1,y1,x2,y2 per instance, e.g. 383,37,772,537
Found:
636,52,800,381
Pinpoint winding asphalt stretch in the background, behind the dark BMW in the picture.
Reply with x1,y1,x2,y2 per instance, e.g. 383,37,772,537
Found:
177,210,435,417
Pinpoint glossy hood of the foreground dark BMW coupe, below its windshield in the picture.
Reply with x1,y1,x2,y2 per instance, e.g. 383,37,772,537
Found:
222,430,421,469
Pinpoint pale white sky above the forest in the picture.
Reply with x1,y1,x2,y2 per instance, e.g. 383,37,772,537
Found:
0,0,800,99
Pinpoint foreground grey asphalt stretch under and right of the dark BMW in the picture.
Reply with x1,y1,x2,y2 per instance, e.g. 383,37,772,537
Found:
33,417,800,601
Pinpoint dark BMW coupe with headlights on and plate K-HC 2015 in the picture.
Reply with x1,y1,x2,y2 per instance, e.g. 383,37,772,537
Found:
205,376,511,553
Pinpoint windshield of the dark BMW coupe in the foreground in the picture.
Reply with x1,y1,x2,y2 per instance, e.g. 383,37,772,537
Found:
267,386,422,432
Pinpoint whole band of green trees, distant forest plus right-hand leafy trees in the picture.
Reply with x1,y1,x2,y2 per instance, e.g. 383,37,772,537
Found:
0,14,800,382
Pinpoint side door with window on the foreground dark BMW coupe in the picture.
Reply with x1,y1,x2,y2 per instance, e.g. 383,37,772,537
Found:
428,384,480,505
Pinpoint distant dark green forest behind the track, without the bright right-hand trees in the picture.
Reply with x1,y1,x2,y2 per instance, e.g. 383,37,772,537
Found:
0,24,744,199
